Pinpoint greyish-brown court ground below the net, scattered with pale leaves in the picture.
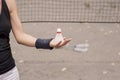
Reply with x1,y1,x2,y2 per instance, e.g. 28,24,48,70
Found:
11,23,120,80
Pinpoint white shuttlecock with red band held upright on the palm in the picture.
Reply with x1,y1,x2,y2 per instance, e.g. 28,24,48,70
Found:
54,28,64,44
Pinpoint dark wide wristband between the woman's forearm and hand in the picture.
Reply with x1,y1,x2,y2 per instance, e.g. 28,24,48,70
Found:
35,38,53,49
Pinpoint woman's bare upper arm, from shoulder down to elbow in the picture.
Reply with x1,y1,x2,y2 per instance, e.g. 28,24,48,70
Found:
6,0,23,38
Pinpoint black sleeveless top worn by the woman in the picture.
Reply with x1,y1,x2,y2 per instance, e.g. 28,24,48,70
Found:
0,0,15,74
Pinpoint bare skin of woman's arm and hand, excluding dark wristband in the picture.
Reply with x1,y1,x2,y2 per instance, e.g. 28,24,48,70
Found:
6,0,71,48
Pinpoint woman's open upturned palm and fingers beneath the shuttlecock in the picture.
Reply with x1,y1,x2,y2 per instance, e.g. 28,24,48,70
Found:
50,38,71,48
